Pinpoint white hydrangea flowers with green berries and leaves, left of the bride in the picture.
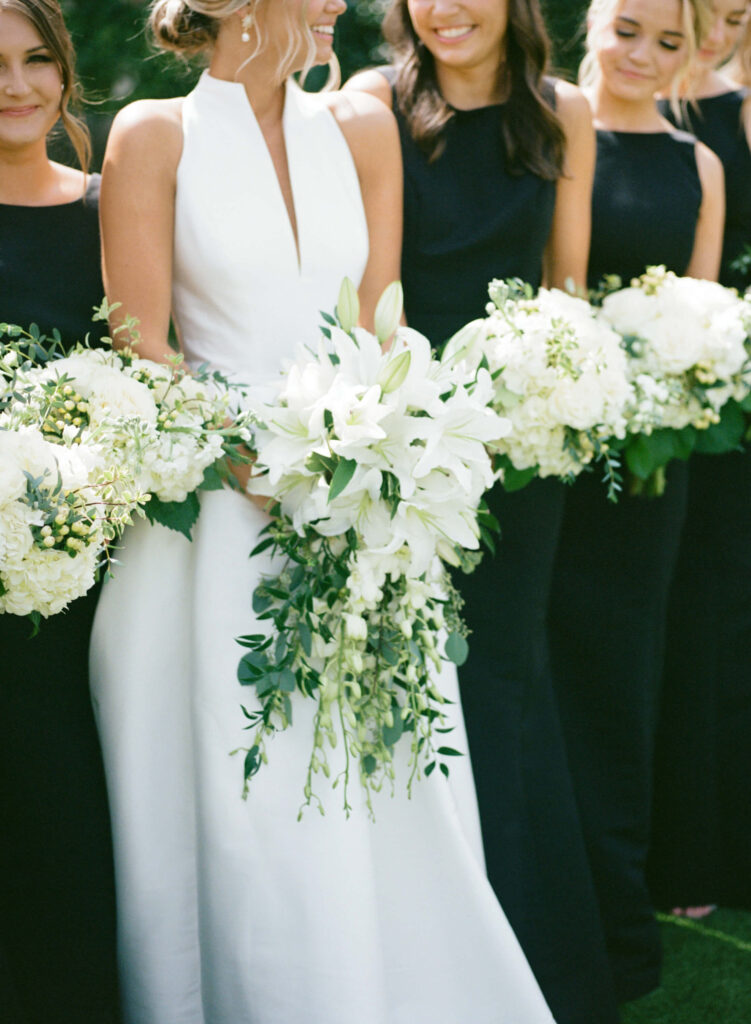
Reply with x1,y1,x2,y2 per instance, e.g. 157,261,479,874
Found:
0,309,249,616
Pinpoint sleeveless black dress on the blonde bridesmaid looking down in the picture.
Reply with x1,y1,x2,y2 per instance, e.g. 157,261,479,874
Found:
550,131,702,1001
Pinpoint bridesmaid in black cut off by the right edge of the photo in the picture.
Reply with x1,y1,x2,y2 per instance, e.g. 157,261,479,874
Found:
650,0,751,918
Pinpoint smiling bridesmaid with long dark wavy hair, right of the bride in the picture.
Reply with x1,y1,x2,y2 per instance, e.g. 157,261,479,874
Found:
347,8,616,1024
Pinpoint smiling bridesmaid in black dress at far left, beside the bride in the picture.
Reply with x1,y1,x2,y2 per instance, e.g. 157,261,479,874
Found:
0,0,118,1024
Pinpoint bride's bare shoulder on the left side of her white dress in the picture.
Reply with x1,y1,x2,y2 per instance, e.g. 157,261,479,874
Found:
108,96,183,168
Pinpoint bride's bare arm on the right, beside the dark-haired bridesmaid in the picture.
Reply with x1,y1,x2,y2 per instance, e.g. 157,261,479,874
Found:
331,91,403,330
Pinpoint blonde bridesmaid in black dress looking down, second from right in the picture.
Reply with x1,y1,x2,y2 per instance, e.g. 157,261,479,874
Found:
550,0,723,1001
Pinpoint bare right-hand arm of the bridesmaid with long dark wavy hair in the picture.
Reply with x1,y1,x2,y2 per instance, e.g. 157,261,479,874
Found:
545,82,595,289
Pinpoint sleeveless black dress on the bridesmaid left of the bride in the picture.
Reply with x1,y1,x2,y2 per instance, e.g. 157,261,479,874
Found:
0,176,118,1024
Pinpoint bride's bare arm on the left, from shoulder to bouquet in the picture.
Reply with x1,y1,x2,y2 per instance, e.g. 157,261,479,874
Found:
99,100,182,361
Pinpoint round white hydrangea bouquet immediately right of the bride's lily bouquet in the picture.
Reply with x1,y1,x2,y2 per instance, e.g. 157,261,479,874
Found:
444,281,631,500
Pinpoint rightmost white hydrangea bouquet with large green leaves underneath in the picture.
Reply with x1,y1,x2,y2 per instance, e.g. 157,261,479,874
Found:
599,266,751,494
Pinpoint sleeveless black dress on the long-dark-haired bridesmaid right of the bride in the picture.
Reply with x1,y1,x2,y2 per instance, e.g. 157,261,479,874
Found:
386,70,617,1024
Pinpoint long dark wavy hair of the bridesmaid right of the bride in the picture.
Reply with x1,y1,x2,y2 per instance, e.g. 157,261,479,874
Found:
383,0,566,180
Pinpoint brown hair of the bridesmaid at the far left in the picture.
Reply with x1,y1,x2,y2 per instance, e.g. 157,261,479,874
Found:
0,0,91,174
